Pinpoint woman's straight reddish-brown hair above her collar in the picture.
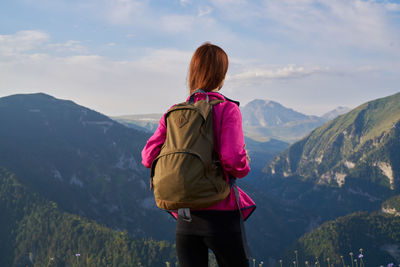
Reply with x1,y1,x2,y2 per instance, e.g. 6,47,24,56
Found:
188,43,229,94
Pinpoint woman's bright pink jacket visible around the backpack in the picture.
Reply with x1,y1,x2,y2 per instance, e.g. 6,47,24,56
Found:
142,92,255,219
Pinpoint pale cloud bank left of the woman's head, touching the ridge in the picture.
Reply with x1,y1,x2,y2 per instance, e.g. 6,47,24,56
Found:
0,33,191,115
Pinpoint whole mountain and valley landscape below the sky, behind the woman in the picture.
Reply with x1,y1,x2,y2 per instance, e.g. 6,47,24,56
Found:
0,93,400,266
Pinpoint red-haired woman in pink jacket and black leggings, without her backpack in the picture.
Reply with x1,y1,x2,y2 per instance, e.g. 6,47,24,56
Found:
142,43,255,267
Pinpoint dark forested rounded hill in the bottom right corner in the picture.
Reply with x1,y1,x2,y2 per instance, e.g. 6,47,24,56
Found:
283,212,400,266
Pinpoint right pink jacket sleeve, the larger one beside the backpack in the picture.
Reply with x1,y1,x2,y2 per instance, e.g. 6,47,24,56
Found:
219,103,250,178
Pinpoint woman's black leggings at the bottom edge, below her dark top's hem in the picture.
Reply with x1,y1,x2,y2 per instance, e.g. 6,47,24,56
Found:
176,233,249,267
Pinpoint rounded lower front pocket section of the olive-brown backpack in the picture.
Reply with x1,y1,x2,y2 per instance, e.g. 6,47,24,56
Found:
152,150,229,210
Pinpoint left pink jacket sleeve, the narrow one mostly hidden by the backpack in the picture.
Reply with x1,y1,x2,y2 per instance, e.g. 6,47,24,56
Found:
142,114,167,168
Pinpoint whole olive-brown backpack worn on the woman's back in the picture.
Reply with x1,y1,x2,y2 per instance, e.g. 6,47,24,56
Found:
150,90,230,210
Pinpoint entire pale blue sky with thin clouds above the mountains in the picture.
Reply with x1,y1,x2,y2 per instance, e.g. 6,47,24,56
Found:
0,0,400,116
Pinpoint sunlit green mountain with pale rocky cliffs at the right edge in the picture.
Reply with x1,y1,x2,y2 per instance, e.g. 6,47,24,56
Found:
266,93,400,195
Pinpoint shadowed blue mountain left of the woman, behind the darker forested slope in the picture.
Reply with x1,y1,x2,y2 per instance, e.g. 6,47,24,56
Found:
0,93,174,240
